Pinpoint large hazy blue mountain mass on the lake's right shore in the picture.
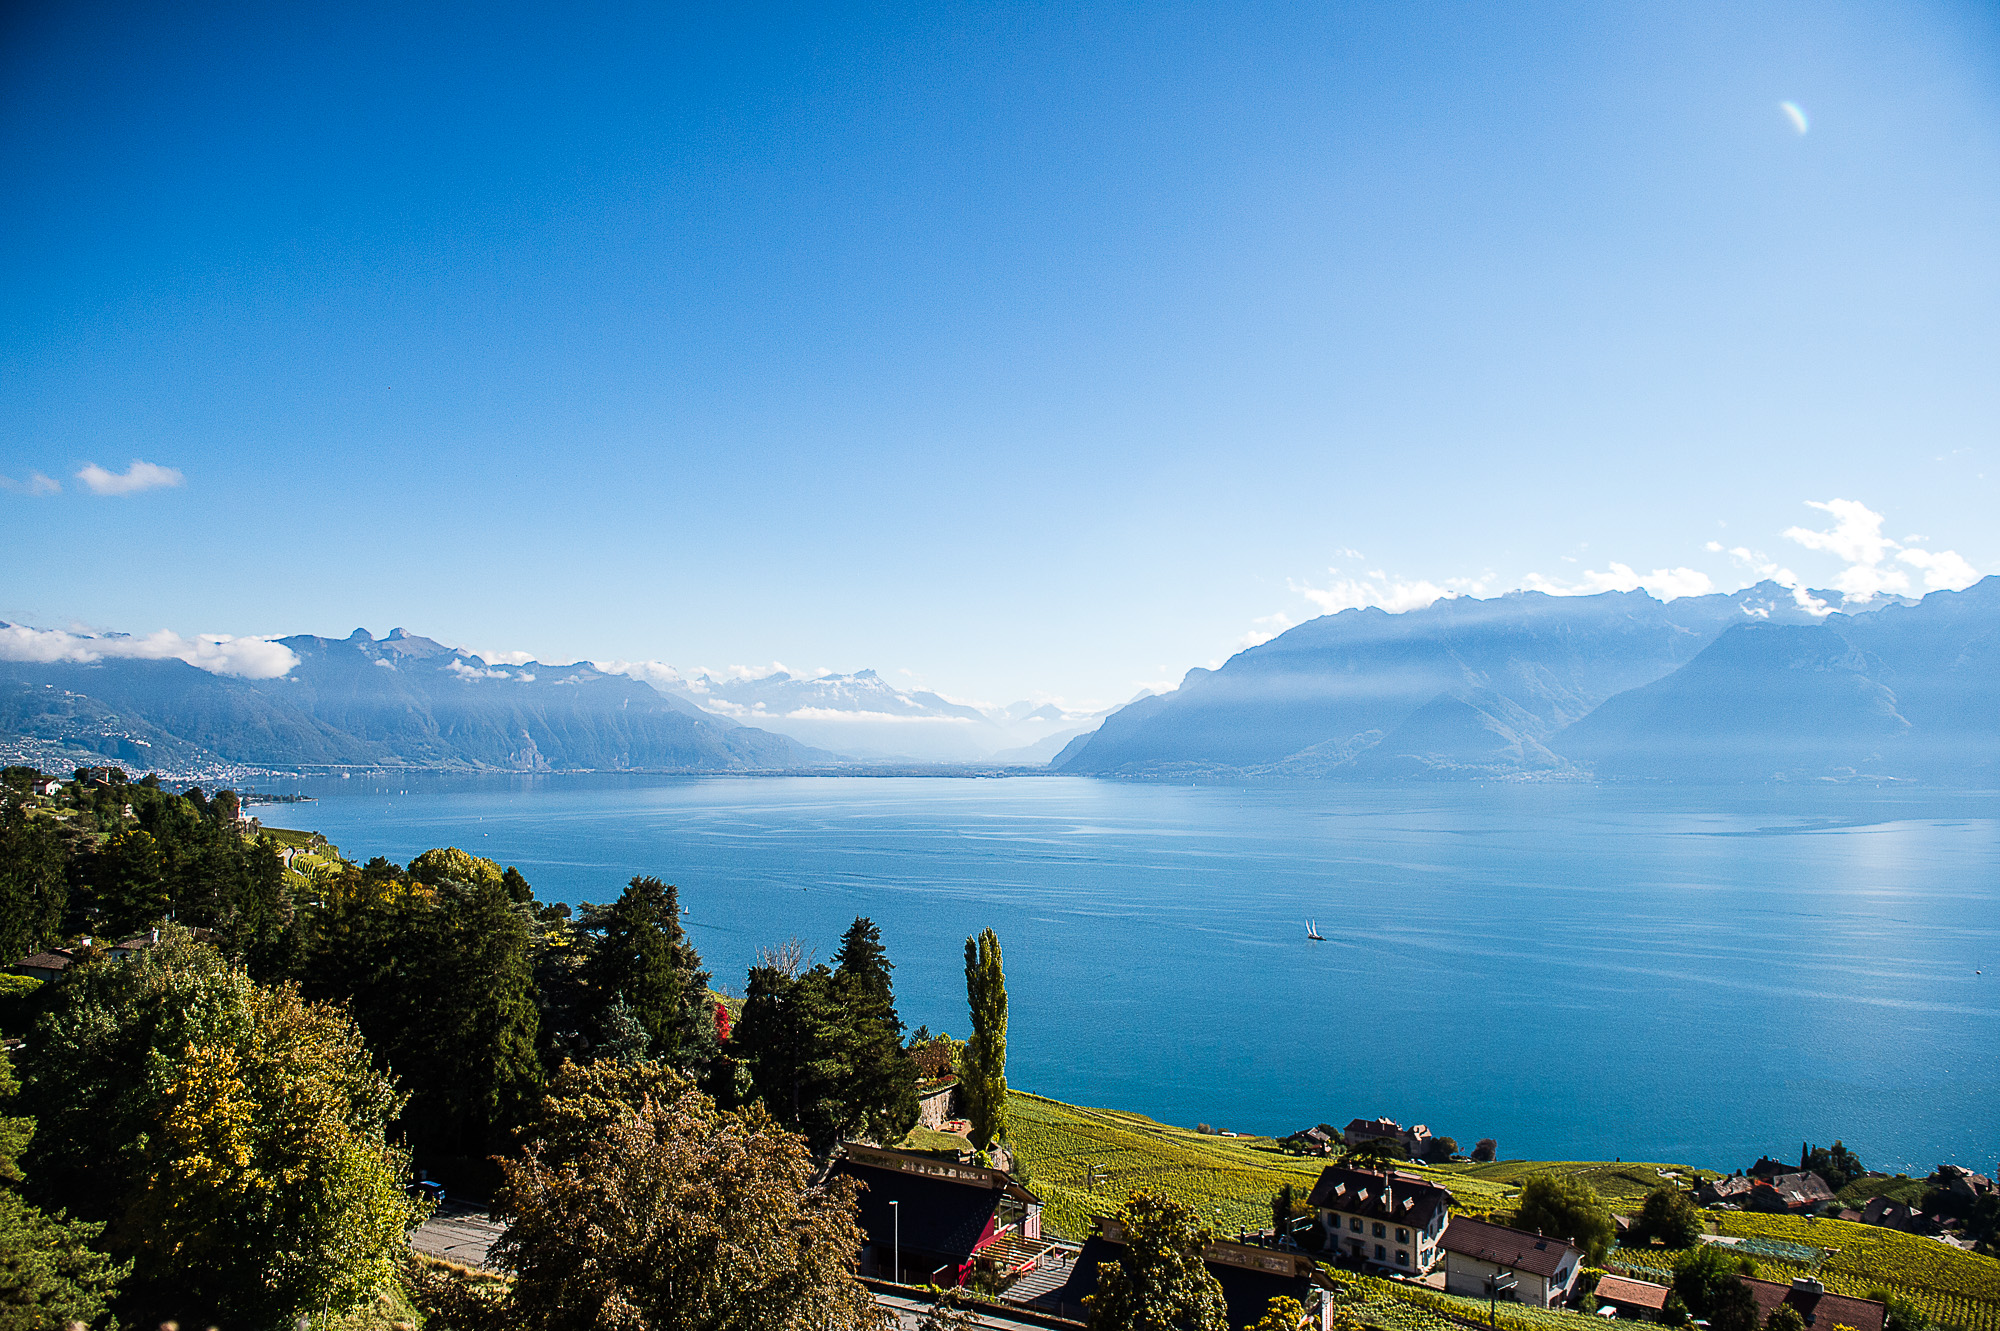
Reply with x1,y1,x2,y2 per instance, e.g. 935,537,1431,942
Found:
1052,578,2000,779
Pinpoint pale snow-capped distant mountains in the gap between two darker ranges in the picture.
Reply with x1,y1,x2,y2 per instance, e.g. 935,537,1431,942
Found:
656,669,1104,765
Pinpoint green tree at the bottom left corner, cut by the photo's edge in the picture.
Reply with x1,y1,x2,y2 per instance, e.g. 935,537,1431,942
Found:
0,1049,132,1331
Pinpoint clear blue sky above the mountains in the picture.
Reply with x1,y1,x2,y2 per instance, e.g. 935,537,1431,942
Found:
0,2,2000,701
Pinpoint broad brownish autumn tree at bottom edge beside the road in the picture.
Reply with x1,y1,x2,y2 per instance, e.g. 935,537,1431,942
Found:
494,1061,884,1331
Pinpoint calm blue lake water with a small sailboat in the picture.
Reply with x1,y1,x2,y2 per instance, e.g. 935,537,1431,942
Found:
258,775,2000,1171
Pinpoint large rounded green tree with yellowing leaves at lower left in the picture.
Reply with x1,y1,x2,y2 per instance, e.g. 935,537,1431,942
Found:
26,927,414,1325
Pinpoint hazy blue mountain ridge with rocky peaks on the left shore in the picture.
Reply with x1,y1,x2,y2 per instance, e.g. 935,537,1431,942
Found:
0,630,836,771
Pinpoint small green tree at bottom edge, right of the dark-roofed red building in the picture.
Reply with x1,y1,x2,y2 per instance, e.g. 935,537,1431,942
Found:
1084,1193,1228,1331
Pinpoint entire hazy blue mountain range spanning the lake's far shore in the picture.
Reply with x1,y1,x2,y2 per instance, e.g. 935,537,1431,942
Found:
0,578,2000,783
